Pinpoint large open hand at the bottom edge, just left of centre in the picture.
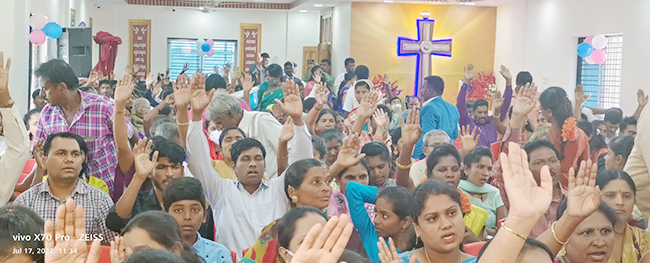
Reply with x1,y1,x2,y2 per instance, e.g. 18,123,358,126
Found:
291,214,353,263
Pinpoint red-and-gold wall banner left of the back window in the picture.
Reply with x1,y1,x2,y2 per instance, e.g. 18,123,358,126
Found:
129,19,151,79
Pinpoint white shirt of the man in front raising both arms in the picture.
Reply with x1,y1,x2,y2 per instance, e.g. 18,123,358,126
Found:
186,121,314,255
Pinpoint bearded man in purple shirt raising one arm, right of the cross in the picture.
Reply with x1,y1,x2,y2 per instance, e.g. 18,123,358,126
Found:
456,64,507,147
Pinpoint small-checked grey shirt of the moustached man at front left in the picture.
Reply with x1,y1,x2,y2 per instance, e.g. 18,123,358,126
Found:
13,179,118,244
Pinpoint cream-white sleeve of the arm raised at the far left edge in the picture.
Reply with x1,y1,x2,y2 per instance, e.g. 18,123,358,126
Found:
0,106,30,206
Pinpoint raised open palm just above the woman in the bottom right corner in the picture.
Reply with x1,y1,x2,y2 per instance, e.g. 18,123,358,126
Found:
564,160,601,221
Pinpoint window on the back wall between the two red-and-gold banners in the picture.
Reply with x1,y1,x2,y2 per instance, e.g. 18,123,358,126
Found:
167,38,237,81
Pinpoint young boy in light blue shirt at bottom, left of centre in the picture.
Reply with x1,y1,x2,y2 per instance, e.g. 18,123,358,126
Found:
163,177,232,263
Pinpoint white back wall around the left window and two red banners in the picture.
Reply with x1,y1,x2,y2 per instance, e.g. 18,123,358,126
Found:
93,4,319,76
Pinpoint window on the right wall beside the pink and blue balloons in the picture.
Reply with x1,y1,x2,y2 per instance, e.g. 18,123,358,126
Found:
577,34,623,109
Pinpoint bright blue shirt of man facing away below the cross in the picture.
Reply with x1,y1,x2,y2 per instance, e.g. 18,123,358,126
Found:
412,97,460,159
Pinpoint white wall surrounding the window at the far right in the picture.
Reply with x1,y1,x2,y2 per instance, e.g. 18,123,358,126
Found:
495,0,650,115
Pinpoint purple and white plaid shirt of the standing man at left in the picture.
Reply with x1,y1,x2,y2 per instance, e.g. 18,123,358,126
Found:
32,91,133,192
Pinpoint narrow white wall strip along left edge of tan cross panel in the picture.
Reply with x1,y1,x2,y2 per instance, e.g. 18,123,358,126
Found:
332,2,352,76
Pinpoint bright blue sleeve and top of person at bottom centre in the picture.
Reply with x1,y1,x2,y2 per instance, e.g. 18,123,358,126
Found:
345,182,399,263
